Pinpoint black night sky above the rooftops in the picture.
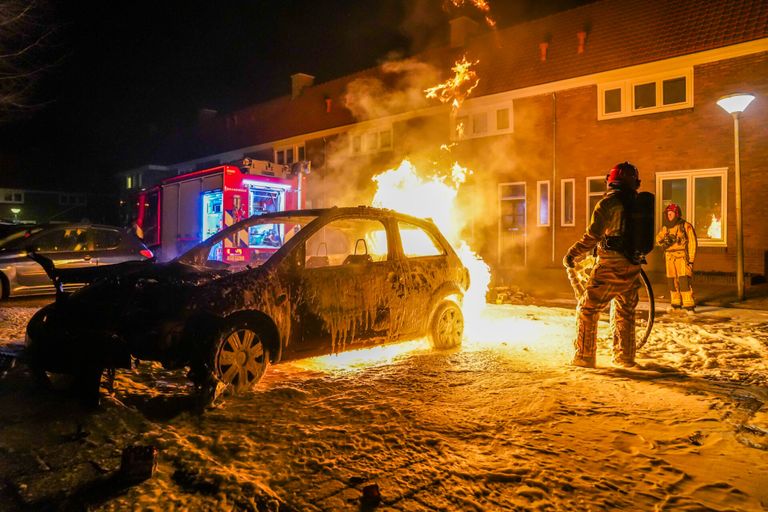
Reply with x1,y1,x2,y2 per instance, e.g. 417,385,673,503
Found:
0,0,588,191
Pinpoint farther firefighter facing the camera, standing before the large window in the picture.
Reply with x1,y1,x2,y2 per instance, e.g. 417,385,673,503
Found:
656,203,698,313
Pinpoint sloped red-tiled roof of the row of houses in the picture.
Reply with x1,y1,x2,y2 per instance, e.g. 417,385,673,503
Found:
153,0,768,162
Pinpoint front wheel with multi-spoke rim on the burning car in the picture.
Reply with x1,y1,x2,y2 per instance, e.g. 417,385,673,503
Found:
214,322,269,394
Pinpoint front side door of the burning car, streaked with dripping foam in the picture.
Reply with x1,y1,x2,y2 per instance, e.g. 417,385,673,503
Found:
287,216,397,358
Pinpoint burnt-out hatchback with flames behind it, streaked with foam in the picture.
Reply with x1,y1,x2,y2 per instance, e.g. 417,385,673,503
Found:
27,207,469,401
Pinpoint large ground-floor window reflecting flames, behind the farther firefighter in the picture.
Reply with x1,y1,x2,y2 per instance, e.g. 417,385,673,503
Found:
656,169,728,247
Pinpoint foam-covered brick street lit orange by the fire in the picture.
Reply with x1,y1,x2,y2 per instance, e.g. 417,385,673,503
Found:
0,305,768,511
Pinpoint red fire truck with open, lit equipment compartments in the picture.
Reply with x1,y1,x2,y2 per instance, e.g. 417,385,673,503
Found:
136,159,309,261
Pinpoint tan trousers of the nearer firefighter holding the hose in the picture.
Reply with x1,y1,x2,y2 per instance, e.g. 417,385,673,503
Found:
574,256,642,363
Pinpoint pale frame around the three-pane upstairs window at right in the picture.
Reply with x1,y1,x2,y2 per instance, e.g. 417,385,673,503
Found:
597,67,693,121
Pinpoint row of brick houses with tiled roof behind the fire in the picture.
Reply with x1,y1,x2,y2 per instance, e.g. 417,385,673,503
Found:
132,0,768,276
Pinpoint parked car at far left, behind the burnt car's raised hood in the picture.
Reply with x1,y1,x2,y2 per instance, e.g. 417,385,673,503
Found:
0,224,152,298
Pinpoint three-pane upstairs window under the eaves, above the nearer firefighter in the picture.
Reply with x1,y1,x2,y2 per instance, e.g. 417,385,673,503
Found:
597,68,693,120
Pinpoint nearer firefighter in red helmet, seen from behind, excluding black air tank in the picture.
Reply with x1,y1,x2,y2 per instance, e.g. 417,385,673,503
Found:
563,162,652,368
